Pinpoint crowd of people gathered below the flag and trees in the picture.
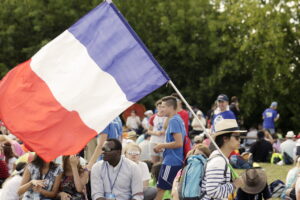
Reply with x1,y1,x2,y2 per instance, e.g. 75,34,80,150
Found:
0,94,300,200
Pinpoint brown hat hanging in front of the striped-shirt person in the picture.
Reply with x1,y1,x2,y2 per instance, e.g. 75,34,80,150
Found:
241,168,267,194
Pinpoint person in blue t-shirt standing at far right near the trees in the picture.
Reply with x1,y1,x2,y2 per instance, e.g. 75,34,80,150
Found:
262,101,279,134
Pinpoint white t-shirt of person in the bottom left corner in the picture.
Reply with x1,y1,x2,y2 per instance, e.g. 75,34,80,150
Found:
0,175,22,200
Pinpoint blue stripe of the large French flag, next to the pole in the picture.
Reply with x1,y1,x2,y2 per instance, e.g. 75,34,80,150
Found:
68,2,169,102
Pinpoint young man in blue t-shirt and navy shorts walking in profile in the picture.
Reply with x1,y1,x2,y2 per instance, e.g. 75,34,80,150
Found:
154,96,186,200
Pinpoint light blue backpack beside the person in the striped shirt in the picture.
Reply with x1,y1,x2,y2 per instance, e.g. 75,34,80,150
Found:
178,155,207,200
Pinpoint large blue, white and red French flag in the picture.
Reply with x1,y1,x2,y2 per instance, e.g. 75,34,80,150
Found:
0,2,169,161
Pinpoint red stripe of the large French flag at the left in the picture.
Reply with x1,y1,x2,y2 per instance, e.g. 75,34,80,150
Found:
0,60,97,161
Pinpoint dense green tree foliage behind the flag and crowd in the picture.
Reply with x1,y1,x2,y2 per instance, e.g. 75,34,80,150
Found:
0,0,300,130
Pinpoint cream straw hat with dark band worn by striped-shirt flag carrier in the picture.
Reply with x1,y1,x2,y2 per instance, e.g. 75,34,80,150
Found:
214,119,247,137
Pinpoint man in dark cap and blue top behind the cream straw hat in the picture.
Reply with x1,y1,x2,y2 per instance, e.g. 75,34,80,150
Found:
212,94,236,133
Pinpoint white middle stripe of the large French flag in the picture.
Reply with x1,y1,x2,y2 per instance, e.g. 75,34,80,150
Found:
31,31,133,132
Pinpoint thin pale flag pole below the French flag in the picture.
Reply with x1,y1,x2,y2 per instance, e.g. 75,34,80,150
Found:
168,80,239,178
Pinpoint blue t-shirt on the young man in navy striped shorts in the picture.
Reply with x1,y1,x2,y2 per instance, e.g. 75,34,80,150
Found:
163,114,186,166
